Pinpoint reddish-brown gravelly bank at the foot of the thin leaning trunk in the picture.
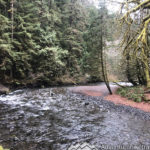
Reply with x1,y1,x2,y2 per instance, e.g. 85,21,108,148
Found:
69,84,150,112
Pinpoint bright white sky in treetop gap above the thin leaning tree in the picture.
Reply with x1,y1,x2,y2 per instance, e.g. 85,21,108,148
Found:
93,0,123,12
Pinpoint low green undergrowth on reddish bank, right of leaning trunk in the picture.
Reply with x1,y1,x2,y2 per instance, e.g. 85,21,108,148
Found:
117,86,144,102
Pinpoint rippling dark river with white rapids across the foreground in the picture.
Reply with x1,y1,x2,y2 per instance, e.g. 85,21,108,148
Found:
0,87,150,150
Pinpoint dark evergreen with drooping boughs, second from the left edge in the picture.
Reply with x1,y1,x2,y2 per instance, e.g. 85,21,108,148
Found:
12,0,39,79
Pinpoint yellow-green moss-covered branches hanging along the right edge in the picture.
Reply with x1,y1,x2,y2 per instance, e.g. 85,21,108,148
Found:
121,0,150,87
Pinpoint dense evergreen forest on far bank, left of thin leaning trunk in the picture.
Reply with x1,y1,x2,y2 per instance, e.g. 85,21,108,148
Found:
0,0,111,86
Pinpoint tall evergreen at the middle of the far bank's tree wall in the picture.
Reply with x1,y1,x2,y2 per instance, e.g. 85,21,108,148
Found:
61,1,86,76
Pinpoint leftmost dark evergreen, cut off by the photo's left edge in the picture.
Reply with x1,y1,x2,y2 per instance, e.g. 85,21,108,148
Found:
0,13,12,82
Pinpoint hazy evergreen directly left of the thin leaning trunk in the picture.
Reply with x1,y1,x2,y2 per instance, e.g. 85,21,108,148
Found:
83,3,107,81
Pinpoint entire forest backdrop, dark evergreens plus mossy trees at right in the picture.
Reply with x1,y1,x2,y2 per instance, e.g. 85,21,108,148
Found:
0,0,150,87
